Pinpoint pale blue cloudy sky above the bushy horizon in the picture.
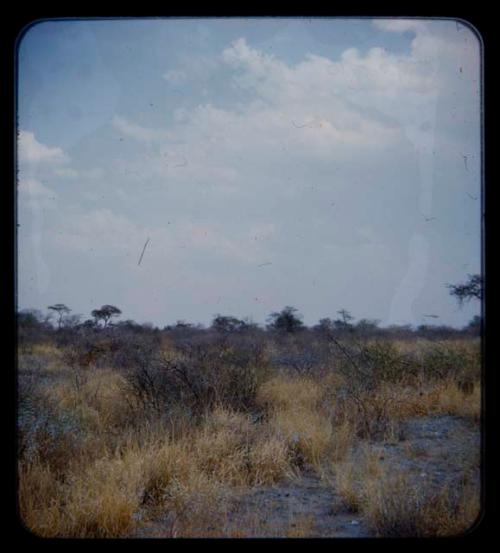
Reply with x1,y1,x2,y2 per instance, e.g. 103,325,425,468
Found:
17,18,481,327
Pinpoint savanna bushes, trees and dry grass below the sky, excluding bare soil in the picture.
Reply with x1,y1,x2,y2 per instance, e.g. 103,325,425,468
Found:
17,296,481,537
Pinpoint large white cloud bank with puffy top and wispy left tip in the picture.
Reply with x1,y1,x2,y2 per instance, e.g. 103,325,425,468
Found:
124,29,437,175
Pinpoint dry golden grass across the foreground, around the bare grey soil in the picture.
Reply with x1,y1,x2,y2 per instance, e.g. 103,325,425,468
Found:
19,334,481,537
